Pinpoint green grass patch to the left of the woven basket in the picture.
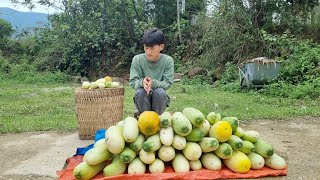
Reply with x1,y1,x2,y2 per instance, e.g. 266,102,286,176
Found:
0,81,77,133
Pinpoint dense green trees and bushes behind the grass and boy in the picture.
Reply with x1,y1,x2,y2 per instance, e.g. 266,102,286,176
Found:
0,0,320,98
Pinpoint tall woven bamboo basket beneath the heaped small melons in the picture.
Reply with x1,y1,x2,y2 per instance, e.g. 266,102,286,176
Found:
75,88,124,139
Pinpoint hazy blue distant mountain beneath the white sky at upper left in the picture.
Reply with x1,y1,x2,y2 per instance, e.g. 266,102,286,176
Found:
0,7,48,33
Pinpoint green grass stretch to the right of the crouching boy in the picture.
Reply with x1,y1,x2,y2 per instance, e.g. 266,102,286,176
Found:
167,84,320,120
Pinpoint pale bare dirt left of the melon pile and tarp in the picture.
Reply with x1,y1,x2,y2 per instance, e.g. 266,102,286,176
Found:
0,132,93,180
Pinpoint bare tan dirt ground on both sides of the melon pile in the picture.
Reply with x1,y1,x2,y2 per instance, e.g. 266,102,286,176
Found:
0,117,320,180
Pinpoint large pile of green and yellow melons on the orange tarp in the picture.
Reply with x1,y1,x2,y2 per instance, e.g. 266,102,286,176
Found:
73,107,287,179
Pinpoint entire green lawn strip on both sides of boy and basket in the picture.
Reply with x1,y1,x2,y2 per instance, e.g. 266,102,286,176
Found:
0,77,320,133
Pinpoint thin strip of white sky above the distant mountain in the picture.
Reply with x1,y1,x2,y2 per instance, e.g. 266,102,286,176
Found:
0,0,61,14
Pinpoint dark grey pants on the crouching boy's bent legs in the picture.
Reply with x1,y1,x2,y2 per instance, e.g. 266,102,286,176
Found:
133,88,170,115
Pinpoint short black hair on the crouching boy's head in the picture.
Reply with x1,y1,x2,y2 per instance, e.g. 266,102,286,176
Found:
143,28,165,47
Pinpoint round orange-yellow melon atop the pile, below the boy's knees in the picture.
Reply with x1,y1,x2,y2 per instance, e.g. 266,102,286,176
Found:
138,111,160,136
